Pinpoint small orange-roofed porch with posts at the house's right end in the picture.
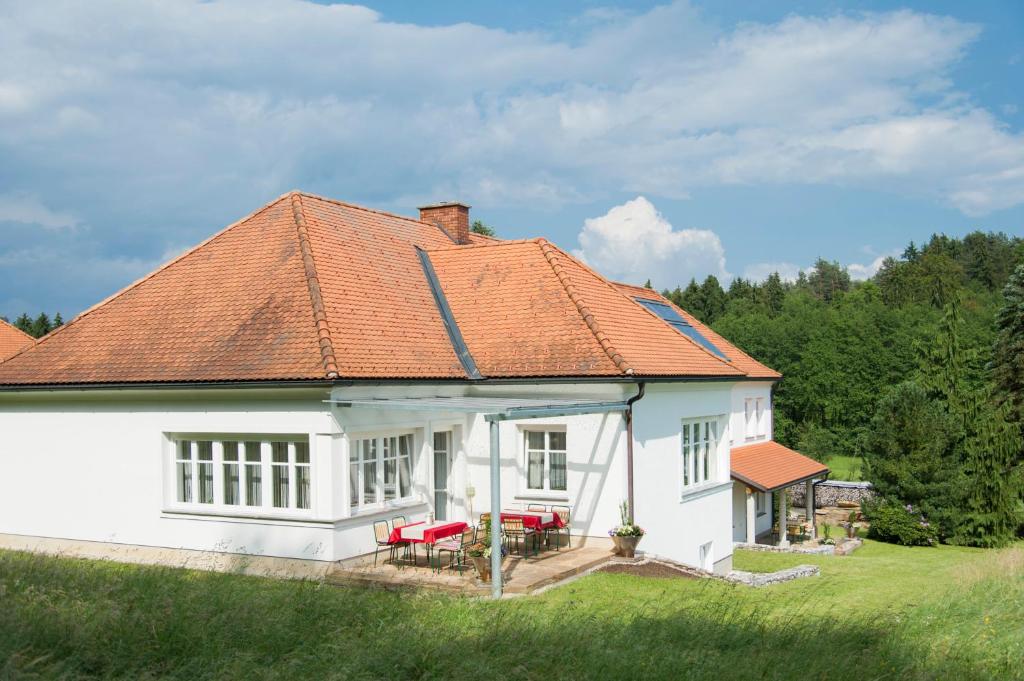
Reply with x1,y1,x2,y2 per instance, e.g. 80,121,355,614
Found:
730,440,828,547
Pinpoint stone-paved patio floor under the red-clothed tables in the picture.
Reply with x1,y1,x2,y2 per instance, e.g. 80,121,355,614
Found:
326,538,612,596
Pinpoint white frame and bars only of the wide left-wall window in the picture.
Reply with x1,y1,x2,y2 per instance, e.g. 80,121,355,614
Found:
167,433,315,518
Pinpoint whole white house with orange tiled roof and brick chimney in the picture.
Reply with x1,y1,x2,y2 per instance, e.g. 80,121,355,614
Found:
0,193,821,589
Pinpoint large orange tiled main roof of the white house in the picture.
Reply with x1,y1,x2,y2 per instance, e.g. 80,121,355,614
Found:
0,191,778,385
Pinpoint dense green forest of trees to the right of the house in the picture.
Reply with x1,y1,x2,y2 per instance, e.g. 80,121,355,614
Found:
663,231,1024,546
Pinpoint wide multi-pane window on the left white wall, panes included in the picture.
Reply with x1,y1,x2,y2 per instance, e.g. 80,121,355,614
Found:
174,437,312,510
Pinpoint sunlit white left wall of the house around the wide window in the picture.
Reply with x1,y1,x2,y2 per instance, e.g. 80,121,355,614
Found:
0,391,337,560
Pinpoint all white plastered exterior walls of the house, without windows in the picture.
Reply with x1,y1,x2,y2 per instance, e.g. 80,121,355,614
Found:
0,374,770,568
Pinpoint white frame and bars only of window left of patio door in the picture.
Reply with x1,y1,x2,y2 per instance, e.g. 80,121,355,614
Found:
348,430,418,516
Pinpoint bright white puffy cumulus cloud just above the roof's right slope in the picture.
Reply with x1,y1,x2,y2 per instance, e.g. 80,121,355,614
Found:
573,197,732,288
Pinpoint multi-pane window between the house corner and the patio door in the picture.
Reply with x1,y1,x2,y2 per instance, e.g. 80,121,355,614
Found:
348,433,413,513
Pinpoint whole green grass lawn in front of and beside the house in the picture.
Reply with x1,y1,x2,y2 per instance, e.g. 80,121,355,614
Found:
0,542,1024,680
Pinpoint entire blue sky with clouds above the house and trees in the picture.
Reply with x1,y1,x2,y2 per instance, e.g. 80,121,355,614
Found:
0,0,1024,317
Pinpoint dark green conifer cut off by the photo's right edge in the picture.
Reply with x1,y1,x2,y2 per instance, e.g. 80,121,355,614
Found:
989,264,1024,423
